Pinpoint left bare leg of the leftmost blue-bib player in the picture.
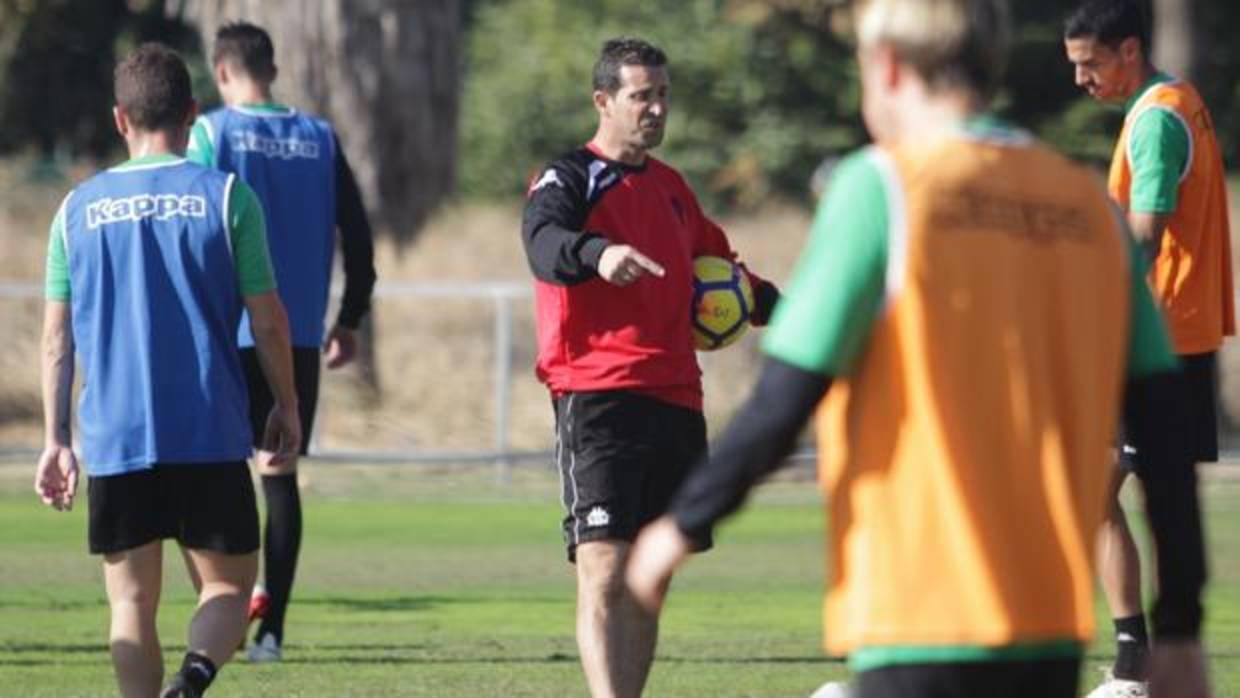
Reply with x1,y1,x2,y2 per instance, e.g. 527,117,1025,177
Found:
103,541,164,698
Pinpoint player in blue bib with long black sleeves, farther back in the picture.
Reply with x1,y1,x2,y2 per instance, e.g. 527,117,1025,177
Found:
188,17,374,661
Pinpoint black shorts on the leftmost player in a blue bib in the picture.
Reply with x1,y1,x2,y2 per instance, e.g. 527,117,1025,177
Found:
87,460,258,554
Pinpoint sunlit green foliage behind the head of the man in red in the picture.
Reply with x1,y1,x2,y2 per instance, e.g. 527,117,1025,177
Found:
460,0,862,206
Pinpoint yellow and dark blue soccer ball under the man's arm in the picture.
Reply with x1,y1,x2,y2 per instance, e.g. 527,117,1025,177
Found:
693,257,754,351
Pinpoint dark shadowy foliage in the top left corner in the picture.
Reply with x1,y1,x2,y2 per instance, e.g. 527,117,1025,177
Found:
0,0,211,161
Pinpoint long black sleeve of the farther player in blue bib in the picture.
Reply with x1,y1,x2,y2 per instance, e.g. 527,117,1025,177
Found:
336,139,374,330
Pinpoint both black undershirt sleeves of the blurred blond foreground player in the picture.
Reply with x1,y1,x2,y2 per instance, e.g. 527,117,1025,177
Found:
671,358,1205,638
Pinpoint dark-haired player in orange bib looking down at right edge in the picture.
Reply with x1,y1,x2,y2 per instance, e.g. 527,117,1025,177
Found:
1064,0,1235,698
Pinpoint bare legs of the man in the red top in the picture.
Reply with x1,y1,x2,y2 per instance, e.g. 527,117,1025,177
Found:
577,541,658,698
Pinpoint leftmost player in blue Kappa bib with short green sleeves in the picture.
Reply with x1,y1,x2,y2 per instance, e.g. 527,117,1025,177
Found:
35,43,301,698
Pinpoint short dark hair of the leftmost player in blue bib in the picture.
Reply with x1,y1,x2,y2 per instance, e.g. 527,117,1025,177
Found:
113,42,193,131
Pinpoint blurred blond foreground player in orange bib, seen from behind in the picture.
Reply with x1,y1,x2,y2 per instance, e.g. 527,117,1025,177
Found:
626,0,1208,698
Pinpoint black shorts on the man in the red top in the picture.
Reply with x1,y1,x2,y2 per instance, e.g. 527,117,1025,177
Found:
554,391,711,562
